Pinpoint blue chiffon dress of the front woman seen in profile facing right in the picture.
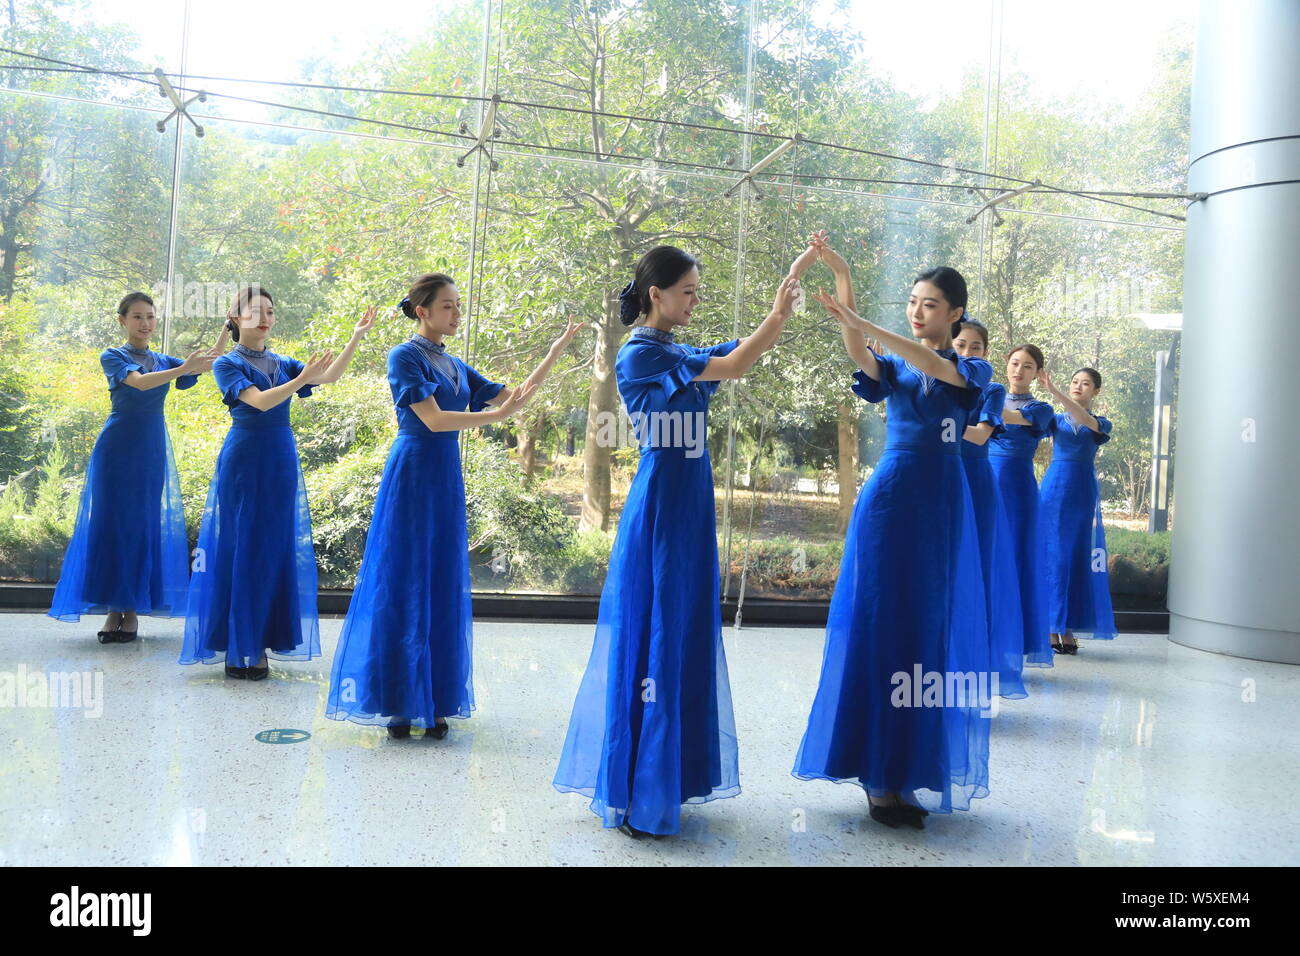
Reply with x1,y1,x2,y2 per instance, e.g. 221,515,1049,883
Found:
554,326,740,834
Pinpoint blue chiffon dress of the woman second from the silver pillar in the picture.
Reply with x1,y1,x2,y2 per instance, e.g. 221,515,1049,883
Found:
988,394,1056,667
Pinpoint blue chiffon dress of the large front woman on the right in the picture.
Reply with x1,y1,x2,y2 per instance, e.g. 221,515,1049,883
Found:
793,350,993,813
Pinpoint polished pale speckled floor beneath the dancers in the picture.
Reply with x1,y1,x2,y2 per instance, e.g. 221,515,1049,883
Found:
0,614,1300,866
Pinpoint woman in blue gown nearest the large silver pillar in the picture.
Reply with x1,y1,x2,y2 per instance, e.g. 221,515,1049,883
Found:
1039,368,1115,654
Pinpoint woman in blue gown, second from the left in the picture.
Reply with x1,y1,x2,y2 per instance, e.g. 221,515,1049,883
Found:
181,286,374,680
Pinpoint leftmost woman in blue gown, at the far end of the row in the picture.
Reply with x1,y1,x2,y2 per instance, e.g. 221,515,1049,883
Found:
49,293,226,644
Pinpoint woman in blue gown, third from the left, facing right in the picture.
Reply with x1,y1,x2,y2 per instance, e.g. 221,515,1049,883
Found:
325,273,582,739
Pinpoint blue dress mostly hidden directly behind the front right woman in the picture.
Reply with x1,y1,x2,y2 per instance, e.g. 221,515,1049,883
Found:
962,382,1028,698
